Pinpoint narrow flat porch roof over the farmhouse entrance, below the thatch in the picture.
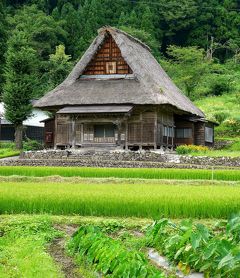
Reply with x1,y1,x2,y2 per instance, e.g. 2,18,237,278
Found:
57,105,133,114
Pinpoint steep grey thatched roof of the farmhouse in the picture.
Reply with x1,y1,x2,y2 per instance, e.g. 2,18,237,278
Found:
34,27,204,117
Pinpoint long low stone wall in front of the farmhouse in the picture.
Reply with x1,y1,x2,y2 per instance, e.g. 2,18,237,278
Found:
4,150,235,168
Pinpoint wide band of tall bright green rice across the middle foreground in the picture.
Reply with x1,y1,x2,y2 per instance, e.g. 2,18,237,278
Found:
0,182,240,218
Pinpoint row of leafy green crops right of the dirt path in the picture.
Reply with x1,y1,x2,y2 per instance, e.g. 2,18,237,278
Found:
68,226,165,278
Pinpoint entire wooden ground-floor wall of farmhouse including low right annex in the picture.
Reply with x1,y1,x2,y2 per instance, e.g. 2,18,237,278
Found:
52,106,210,148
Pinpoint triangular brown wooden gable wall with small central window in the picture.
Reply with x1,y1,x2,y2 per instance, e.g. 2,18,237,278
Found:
83,36,132,75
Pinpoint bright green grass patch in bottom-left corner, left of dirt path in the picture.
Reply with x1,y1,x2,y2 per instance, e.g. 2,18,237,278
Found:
0,216,64,278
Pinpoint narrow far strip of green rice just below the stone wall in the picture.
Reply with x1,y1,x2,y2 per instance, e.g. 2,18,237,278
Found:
0,166,240,181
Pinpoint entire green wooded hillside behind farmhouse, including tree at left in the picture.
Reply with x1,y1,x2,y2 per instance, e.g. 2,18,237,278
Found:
0,0,240,138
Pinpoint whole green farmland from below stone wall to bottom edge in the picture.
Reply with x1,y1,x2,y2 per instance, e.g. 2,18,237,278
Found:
0,167,240,278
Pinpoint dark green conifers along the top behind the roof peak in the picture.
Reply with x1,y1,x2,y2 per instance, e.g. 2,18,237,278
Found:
4,0,240,60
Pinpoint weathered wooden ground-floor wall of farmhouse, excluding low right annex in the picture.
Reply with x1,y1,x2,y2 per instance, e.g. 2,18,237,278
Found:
55,106,174,148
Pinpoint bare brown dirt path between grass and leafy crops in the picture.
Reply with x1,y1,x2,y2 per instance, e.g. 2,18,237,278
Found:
48,225,81,278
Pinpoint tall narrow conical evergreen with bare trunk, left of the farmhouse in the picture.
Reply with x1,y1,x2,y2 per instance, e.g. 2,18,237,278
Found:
3,31,37,149
